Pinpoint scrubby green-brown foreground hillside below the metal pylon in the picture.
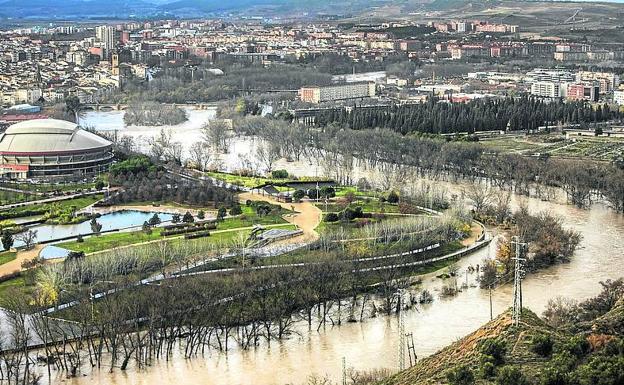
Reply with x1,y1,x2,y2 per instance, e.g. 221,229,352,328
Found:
383,279,624,385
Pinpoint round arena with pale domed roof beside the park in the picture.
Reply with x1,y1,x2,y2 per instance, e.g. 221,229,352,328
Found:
0,119,113,180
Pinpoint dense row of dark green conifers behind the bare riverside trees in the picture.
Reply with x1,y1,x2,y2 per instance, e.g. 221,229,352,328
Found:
315,96,622,135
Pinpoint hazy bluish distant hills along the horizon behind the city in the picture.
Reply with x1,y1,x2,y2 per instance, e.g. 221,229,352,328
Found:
0,0,624,19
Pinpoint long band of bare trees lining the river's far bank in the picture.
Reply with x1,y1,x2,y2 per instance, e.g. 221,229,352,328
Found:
229,117,624,212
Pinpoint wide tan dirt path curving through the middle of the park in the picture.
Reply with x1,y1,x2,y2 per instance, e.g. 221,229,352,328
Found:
239,192,321,242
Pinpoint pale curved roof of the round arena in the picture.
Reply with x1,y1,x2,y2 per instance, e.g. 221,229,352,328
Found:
0,119,112,154
